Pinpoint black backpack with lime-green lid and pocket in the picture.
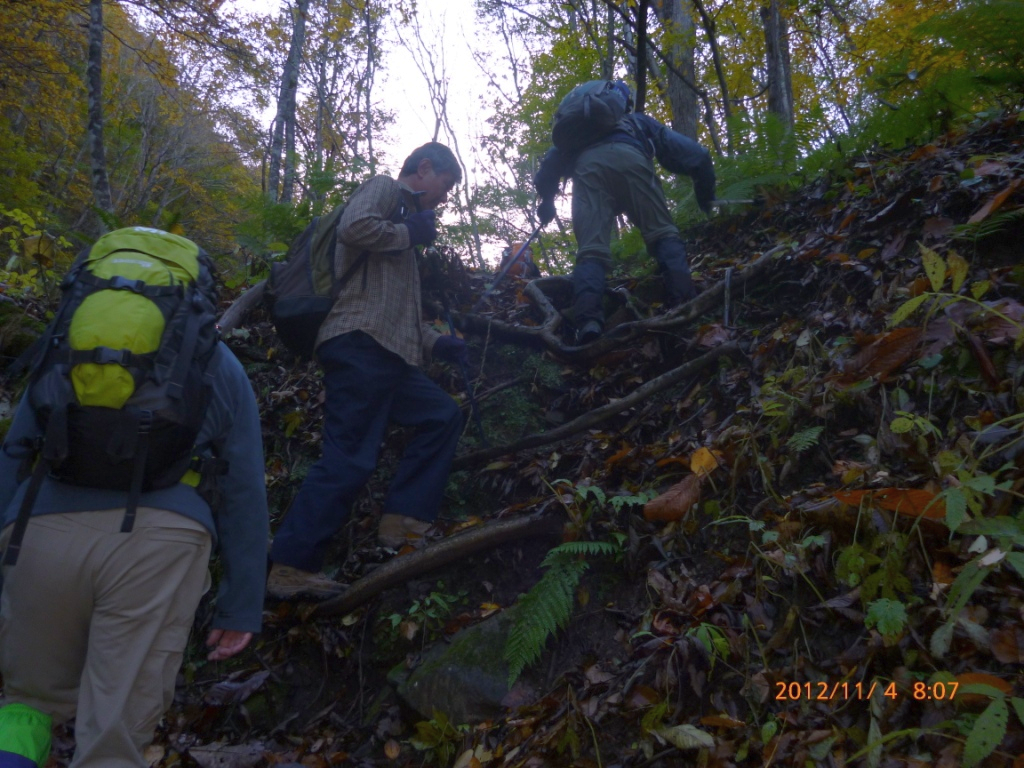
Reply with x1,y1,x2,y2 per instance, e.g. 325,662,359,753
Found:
4,226,219,564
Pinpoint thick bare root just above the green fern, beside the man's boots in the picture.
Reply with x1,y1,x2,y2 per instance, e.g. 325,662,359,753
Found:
315,512,562,617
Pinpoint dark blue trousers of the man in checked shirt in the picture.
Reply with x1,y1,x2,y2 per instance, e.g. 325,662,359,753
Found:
270,331,463,571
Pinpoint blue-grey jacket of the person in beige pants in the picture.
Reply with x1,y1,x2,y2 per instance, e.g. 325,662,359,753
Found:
0,343,269,632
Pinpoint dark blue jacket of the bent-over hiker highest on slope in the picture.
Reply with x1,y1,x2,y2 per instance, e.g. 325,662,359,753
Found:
534,113,715,211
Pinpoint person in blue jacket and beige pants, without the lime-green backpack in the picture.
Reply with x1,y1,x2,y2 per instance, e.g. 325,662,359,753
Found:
0,344,269,768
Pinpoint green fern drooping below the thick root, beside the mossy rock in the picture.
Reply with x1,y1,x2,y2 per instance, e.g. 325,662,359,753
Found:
505,542,620,687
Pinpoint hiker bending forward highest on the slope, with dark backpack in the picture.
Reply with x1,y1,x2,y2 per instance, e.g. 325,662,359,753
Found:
534,80,715,344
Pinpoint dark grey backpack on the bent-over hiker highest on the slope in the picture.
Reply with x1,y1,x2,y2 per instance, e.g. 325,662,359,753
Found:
551,80,631,152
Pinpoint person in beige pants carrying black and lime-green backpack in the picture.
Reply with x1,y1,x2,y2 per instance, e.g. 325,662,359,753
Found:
0,227,268,768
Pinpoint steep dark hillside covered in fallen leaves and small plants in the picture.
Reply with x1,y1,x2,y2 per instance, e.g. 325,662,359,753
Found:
14,117,1024,768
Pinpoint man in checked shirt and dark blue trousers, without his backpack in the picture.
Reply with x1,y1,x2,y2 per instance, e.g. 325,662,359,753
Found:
267,142,466,599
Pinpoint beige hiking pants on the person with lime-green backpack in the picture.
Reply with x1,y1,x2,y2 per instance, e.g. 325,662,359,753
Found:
0,507,210,768
